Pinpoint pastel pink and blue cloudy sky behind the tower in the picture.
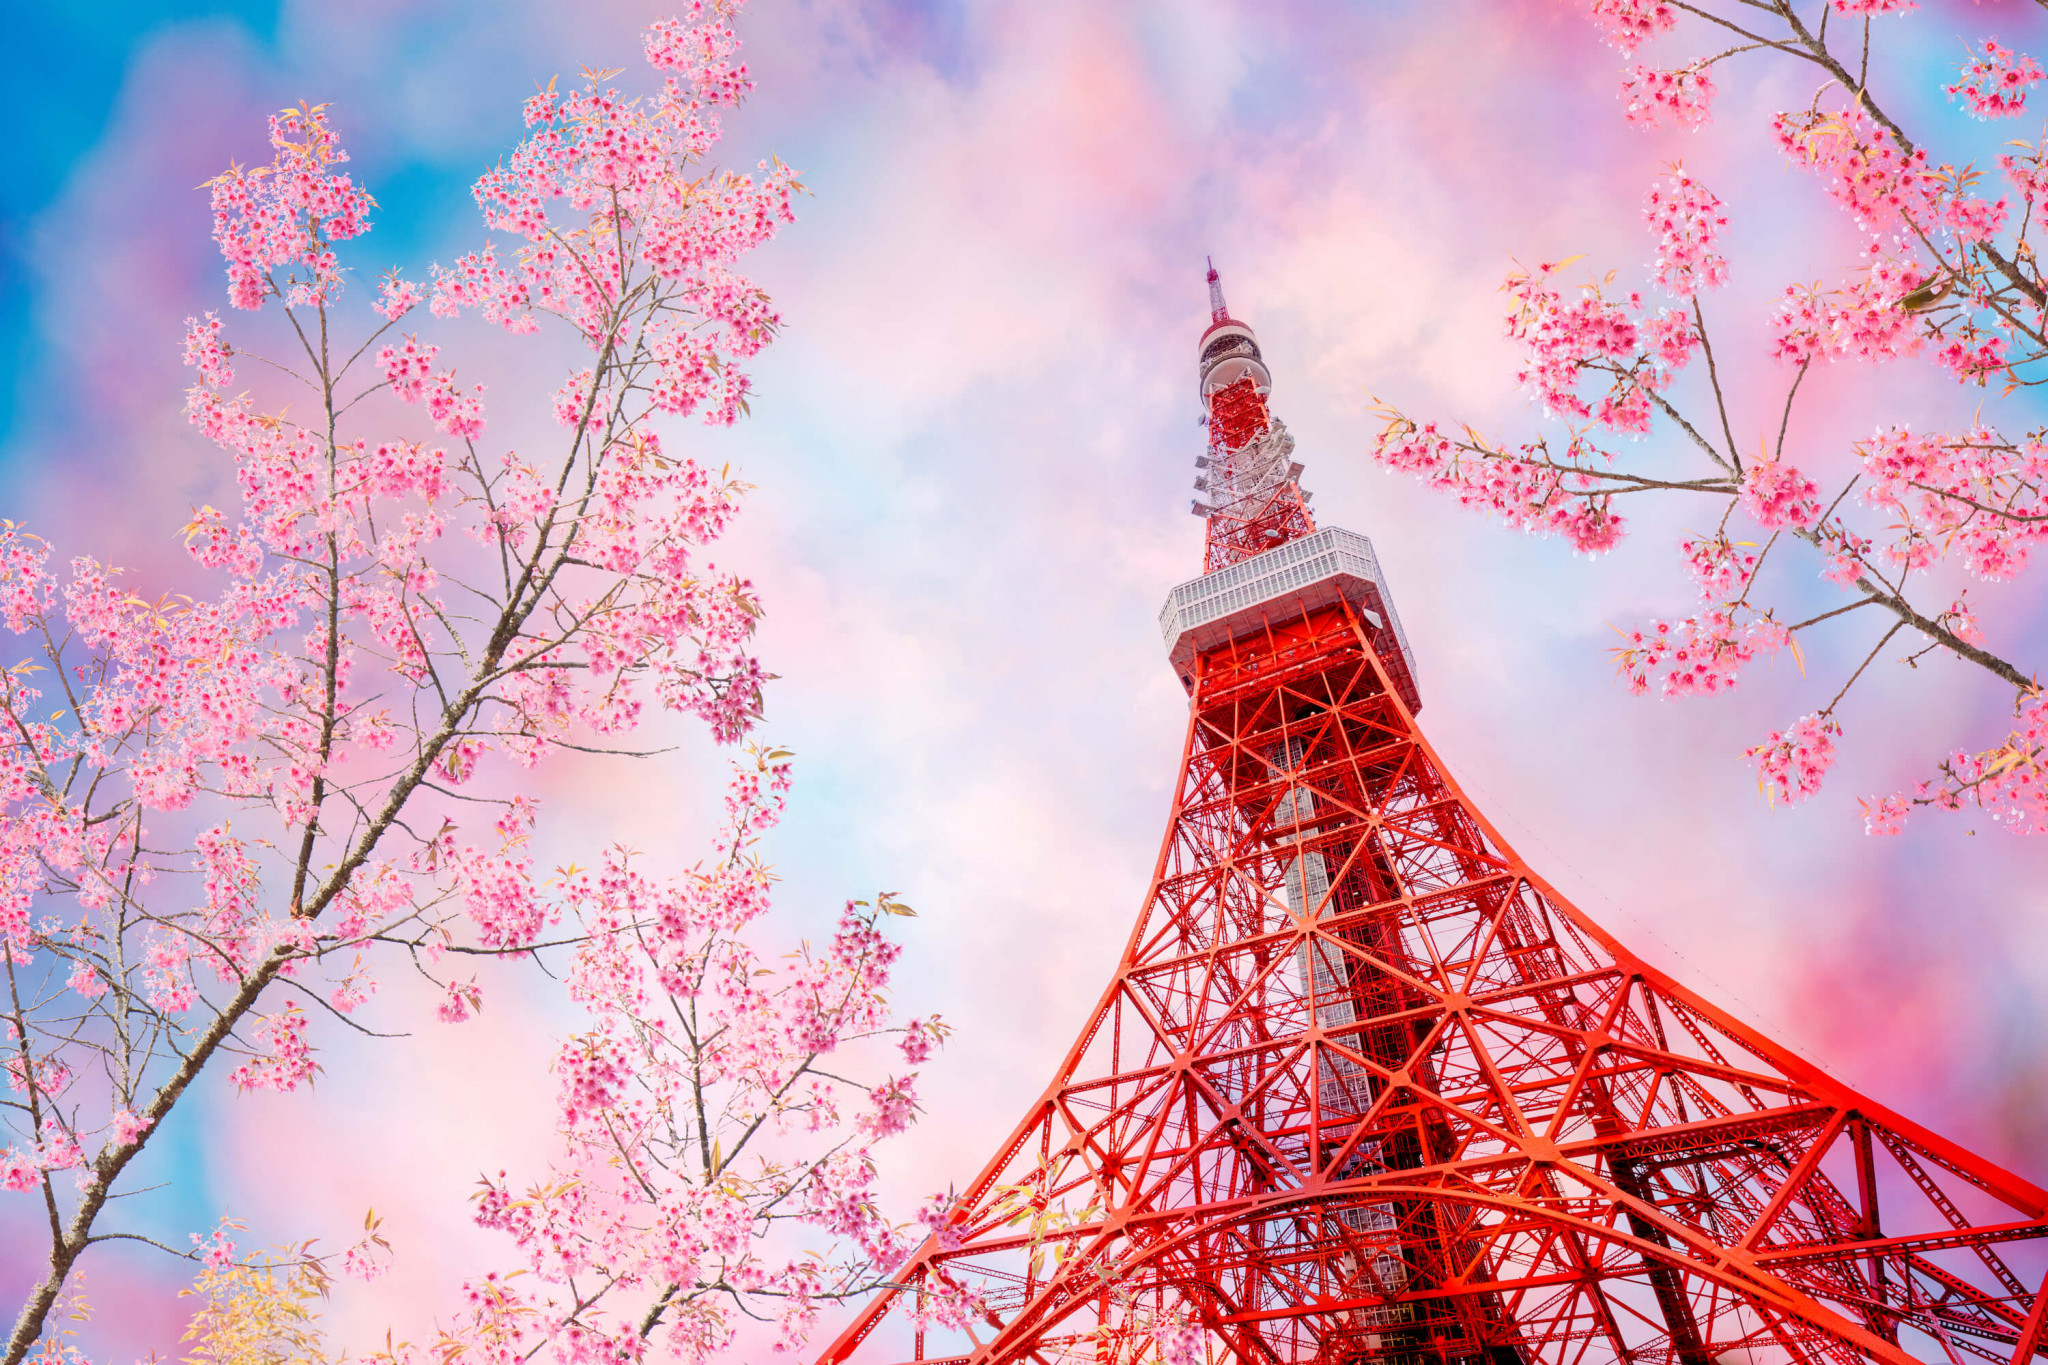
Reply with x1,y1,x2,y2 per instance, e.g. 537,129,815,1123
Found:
0,0,2048,1359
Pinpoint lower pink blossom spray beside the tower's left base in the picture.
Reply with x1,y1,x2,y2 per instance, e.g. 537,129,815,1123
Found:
411,749,946,1361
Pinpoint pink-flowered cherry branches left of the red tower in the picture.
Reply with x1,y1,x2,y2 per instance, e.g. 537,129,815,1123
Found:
0,26,944,1361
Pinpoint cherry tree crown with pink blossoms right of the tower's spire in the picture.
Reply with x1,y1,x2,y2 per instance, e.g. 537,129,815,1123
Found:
1372,0,2048,833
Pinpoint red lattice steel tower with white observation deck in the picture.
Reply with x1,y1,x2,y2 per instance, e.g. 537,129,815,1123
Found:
821,268,2048,1365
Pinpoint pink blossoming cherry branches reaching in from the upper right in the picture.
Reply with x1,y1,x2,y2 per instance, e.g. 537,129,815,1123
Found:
1374,0,2048,829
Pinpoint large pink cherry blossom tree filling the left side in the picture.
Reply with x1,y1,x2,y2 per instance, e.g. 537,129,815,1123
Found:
0,0,944,1365
